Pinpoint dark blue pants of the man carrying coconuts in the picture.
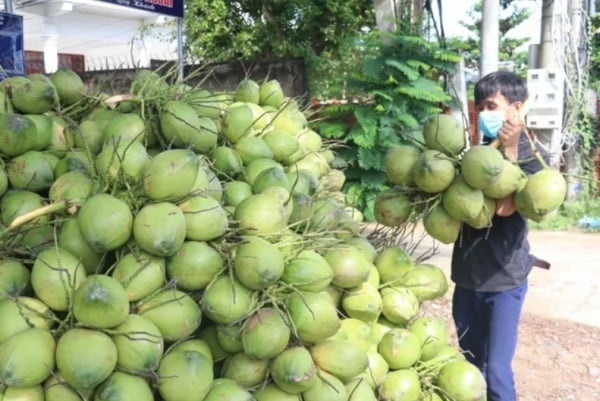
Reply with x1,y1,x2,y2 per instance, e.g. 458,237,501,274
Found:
452,281,527,401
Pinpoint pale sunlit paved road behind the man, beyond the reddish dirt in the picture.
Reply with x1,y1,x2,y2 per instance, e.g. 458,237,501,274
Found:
428,231,600,327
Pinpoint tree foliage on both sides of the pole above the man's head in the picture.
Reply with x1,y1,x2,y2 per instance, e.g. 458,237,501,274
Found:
447,1,531,73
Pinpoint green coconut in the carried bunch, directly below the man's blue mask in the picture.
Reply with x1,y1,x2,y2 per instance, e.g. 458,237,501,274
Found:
461,145,504,189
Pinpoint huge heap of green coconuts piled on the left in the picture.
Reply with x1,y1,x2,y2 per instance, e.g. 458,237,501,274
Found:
0,70,485,401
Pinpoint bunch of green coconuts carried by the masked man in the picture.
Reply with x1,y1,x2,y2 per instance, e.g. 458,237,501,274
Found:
375,114,566,243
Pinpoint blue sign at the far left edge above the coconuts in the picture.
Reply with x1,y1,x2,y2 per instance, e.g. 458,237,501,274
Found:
0,12,25,79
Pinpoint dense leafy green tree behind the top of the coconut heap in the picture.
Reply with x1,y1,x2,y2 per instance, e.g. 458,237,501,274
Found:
184,0,375,97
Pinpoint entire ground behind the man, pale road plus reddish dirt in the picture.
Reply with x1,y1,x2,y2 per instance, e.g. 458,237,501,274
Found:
420,231,600,401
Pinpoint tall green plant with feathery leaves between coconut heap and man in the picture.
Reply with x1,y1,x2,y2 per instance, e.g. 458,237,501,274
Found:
316,33,460,220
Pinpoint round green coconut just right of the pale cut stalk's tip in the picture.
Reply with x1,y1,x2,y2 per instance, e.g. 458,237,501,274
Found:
77,193,133,252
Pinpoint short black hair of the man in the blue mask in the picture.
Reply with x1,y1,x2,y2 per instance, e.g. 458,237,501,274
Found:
474,71,529,105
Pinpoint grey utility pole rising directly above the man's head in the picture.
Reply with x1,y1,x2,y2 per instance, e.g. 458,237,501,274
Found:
479,0,500,77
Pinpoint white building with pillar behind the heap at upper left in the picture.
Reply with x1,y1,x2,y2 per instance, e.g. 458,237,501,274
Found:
0,0,178,73
